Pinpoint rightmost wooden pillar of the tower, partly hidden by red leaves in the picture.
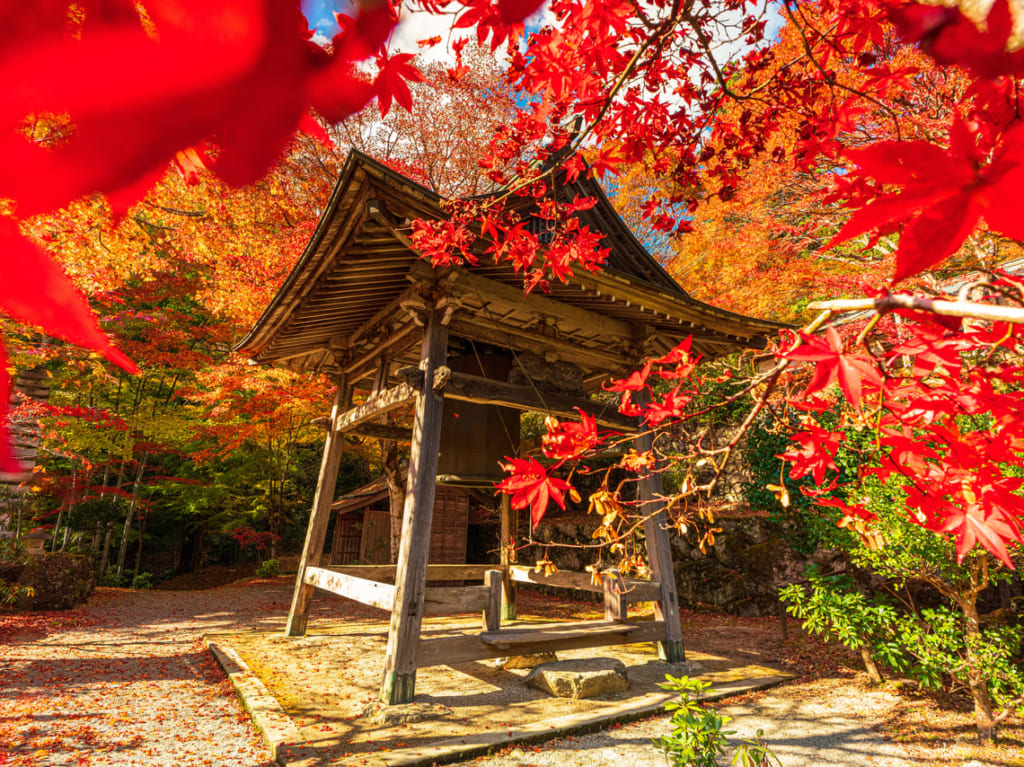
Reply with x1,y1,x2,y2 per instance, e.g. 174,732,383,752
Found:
635,401,686,664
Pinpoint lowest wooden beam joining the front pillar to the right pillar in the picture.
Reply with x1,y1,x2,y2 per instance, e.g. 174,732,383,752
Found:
416,621,665,669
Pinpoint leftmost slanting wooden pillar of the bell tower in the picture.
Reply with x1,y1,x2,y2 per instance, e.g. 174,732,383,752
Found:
285,377,352,637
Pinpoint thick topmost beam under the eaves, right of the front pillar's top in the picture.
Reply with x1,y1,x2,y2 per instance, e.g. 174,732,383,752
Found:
450,270,633,344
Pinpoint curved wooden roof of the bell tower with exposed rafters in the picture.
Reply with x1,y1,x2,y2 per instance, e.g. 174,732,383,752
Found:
236,151,786,386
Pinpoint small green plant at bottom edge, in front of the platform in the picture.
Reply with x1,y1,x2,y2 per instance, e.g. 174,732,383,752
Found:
653,676,779,767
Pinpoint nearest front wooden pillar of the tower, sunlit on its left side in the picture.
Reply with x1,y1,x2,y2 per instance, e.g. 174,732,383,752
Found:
380,309,447,706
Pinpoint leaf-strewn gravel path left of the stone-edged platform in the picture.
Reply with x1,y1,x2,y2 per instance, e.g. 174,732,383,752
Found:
0,583,299,767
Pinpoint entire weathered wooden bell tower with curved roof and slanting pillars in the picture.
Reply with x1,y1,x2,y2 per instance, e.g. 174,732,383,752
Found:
238,152,780,704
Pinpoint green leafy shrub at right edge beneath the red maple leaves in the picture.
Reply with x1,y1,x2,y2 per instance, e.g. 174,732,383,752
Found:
746,408,1024,741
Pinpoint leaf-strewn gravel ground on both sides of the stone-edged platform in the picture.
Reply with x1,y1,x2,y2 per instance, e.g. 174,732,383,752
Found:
0,580,937,767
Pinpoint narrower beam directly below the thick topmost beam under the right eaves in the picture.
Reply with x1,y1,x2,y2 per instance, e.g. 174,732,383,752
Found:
450,313,633,376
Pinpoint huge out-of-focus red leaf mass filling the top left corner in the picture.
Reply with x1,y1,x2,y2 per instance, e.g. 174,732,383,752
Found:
0,0,395,211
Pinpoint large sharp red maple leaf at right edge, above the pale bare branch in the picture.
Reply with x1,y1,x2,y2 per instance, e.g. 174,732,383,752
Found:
825,118,1024,283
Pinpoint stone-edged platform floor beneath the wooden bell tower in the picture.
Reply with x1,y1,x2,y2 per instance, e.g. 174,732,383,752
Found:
205,619,788,767
